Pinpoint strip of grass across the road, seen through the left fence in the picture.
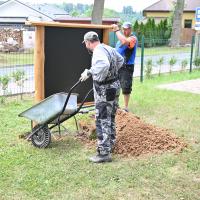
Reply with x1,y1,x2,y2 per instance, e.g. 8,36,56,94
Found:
0,52,33,67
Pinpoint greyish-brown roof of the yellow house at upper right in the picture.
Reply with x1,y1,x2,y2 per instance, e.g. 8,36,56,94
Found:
143,0,200,12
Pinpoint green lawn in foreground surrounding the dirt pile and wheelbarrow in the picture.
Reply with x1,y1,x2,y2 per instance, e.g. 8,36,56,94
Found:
0,71,200,200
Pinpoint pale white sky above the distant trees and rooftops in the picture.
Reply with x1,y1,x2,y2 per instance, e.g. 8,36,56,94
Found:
21,0,158,12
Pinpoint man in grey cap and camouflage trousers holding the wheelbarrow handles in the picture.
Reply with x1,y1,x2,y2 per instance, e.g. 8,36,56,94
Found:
80,31,124,163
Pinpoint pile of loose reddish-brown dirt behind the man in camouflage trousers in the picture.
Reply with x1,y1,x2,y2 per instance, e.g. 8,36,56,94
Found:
78,110,187,156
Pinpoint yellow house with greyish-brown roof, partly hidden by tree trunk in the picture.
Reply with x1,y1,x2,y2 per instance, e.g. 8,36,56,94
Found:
143,0,200,43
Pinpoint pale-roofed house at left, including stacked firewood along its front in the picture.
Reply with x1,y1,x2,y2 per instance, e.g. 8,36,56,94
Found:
0,0,69,49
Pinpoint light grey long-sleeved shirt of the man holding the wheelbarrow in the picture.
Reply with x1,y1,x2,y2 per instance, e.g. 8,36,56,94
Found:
89,44,124,82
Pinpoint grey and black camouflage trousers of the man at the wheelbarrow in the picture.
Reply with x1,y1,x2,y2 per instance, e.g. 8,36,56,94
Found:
93,81,120,155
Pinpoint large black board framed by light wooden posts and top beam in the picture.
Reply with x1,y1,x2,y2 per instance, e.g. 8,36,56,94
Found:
26,22,110,102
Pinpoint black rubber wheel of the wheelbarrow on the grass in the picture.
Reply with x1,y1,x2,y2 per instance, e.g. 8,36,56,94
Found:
31,125,51,148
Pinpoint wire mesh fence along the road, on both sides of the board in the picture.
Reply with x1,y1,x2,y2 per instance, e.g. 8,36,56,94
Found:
0,38,195,96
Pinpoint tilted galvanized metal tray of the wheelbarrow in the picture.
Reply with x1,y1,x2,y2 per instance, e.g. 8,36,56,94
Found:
19,92,77,125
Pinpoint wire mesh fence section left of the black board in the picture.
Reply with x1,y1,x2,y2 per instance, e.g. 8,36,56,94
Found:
0,49,34,96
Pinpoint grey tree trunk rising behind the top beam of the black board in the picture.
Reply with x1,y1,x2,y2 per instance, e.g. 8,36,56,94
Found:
91,0,105,24
